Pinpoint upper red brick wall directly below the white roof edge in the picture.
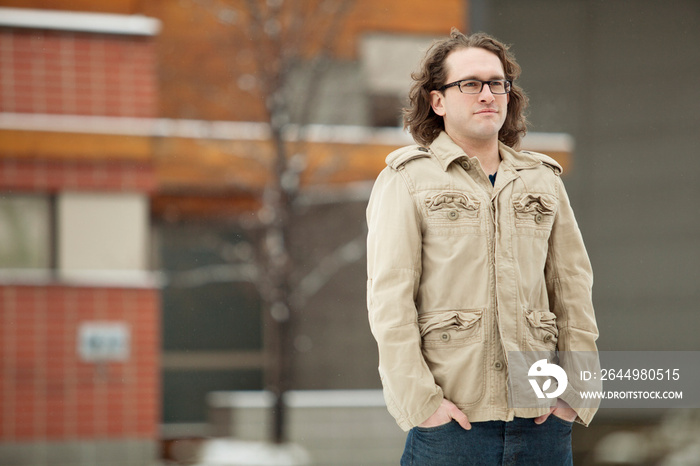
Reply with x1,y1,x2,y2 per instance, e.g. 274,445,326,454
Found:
0,29,157,117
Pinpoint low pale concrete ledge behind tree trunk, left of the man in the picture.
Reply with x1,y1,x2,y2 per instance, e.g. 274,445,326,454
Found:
207,390,406,466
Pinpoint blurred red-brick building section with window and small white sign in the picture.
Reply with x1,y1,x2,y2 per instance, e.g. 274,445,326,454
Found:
0,8,161,465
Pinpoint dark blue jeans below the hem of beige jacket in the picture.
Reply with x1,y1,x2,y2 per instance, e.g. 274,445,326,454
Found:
401,415,573,466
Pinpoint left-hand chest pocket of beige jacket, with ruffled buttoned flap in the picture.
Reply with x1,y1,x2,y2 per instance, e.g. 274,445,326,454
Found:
424,191,481,235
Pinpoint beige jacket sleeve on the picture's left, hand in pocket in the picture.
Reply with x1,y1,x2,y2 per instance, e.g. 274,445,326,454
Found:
367,168,443,431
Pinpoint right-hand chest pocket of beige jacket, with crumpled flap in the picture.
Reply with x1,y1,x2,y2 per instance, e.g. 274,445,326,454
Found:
513,193,557,236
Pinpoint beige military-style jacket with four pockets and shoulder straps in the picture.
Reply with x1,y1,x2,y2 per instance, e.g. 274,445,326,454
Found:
367,132,598,430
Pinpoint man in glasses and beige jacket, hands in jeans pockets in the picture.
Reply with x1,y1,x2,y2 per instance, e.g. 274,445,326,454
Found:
367,29,598,466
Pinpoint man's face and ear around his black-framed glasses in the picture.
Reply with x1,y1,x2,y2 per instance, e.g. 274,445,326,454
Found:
431,48,509,146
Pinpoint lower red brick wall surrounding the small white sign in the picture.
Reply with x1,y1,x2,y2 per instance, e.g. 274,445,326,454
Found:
0,286,160,443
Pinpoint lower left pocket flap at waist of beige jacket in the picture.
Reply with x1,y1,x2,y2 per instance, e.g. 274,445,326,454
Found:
418,309,483,348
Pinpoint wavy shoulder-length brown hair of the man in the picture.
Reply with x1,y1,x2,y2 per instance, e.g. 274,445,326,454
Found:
403,28,528,148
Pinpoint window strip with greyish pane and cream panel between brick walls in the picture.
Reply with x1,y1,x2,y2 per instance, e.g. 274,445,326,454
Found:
0,192,150,283
